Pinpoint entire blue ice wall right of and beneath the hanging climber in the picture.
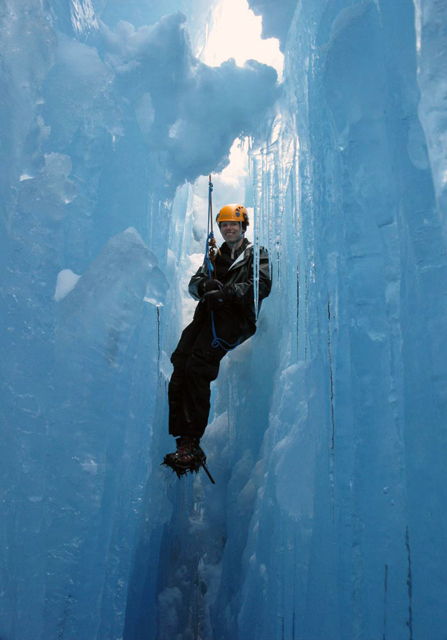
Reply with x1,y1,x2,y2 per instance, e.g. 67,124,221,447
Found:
132,1,447,640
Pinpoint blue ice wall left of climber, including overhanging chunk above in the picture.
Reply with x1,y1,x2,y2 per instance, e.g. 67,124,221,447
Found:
0,0,277,640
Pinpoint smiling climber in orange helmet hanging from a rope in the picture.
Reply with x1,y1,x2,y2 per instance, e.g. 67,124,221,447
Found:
163,204,271,480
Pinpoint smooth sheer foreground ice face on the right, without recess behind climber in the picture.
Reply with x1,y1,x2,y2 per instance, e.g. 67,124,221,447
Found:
238,2,446,638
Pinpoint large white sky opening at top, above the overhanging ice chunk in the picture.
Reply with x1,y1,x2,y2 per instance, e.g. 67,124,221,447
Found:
202,0,284,80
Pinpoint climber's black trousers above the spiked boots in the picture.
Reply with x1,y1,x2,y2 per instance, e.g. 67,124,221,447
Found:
169,303,253,438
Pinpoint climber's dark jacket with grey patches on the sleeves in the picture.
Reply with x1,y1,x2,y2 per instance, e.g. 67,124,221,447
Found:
189,239,272,335
